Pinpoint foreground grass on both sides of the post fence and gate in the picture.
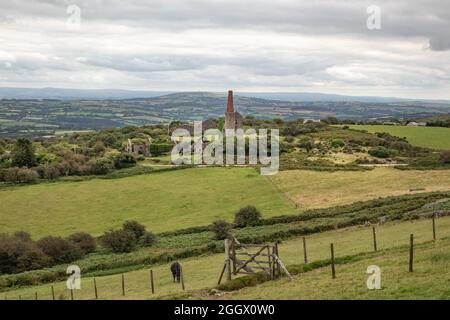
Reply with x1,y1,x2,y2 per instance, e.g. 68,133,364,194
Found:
2,217,450,299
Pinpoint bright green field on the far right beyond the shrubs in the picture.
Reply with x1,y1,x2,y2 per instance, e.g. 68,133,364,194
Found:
349,125,450,150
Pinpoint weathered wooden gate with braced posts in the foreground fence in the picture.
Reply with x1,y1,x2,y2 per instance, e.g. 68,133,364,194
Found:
218,237,292,284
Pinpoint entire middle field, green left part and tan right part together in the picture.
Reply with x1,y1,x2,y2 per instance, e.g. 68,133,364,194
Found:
0,168,450,238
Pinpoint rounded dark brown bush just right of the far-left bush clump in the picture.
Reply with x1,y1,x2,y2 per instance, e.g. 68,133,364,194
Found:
37,236,83,263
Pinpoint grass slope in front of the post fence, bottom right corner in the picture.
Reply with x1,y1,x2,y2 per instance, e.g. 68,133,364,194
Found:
229,237,450,300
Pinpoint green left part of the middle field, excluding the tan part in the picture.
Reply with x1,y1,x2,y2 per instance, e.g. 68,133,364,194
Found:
0,168,295,238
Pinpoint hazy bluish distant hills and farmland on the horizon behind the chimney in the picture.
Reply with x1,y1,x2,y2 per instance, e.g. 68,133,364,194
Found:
0,89,450,137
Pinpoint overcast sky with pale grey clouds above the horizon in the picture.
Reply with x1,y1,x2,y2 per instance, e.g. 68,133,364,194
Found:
0,0,450,99
